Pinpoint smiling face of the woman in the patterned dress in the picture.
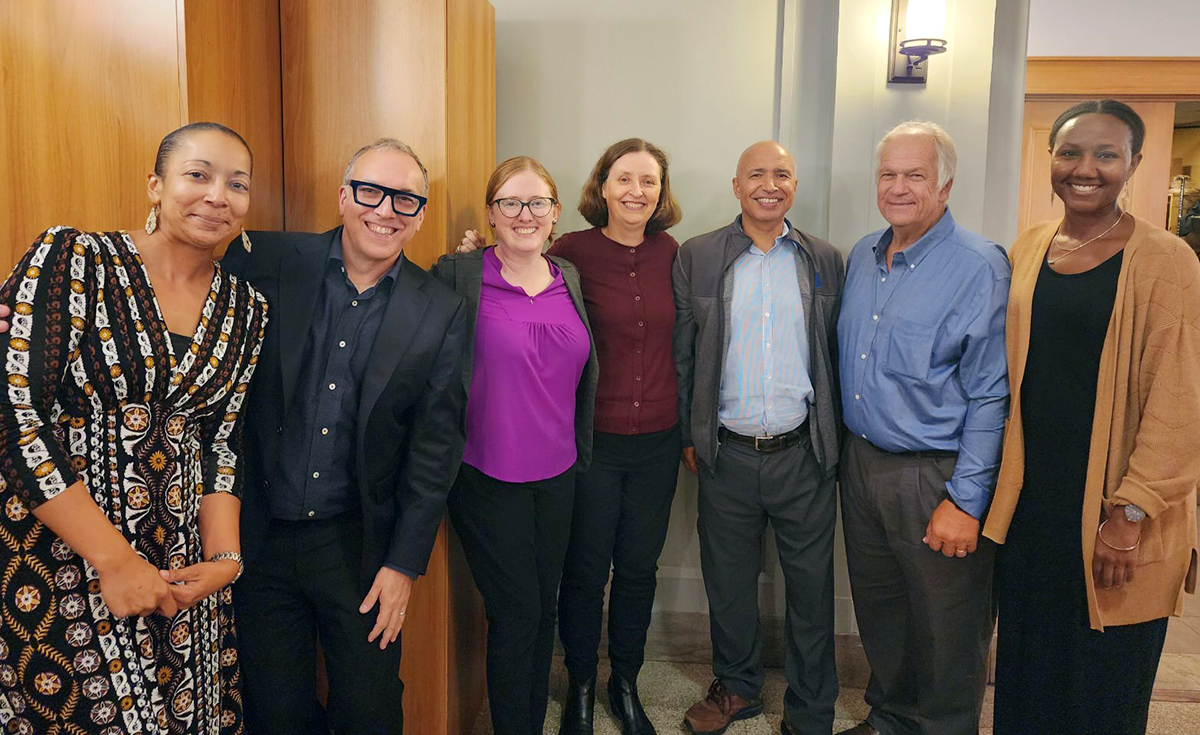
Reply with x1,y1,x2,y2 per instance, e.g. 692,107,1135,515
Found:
149,130,250,250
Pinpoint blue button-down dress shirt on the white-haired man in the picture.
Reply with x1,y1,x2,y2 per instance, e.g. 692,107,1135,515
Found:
838,209,1010,518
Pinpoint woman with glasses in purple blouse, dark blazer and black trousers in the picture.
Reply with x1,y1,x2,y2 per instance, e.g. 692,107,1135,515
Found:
432,156,599,735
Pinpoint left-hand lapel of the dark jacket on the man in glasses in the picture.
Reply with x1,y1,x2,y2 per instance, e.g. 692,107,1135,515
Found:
271,227,326,416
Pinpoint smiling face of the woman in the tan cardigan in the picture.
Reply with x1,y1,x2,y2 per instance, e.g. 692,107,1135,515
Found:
1050,113,1141,214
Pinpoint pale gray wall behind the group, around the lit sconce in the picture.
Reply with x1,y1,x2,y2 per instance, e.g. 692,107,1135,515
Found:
492,0,1030,633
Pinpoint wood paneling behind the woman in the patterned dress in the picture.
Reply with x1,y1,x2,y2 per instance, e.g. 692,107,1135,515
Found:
0,0,283,275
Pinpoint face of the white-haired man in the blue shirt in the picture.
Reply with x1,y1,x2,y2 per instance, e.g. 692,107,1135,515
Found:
876,133,954,237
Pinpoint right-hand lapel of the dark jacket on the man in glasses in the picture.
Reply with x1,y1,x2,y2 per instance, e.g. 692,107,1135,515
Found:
358,253,430,446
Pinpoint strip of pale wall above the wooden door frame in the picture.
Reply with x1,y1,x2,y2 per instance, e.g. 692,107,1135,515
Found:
1028,0,1200,56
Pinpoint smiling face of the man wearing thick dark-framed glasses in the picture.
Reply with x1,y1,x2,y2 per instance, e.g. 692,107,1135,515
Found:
337,149,426,262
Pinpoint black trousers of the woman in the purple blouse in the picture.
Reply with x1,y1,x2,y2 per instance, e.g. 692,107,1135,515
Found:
449,465,575,735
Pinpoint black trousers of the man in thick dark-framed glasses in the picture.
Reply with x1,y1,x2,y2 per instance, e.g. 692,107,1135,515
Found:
234,513,404,735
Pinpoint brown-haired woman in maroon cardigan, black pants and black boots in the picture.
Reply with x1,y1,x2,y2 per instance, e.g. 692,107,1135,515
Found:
460,138,682,735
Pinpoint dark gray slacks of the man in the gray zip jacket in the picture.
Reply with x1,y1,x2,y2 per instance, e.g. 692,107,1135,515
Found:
696,438,838,735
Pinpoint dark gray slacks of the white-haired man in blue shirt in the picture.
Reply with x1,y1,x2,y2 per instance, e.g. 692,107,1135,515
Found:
840,436,996,735
